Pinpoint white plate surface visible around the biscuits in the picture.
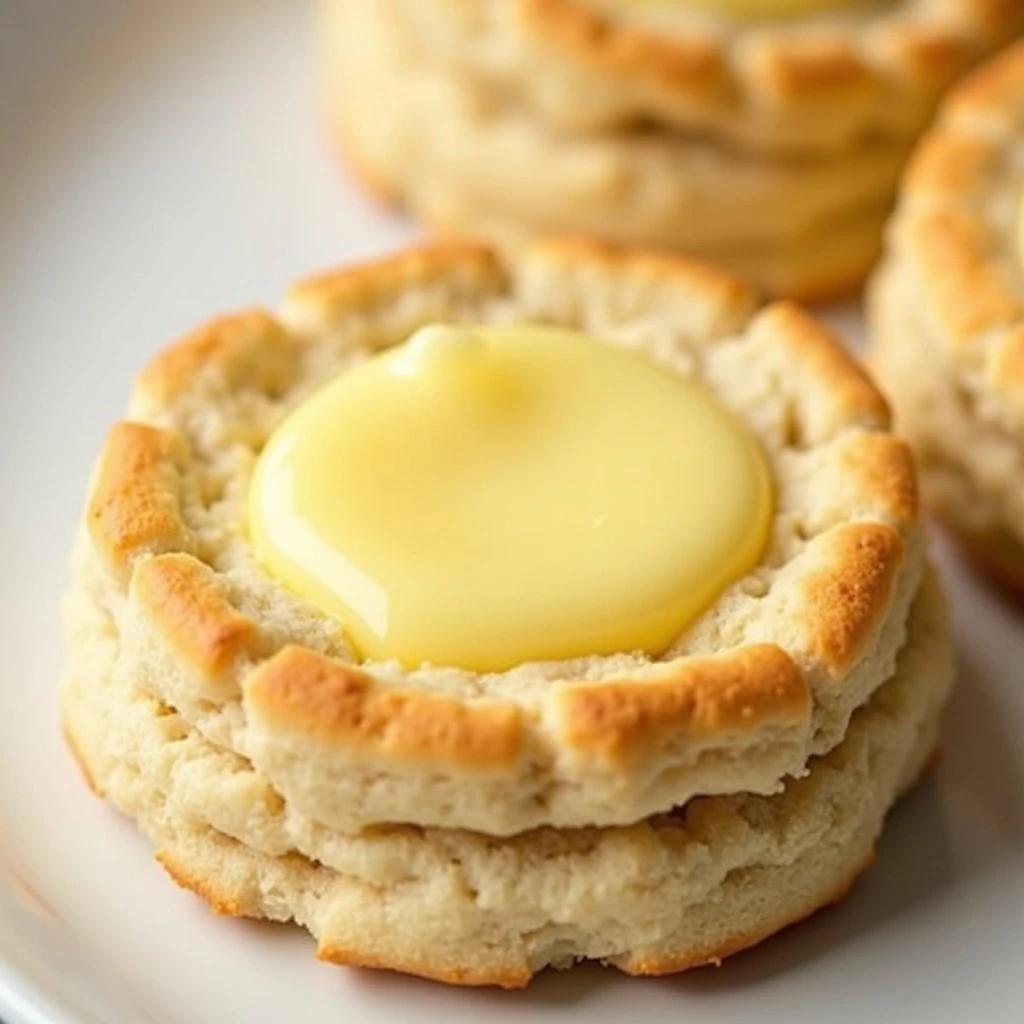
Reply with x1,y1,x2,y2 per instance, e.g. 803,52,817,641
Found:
0,0,1024,1024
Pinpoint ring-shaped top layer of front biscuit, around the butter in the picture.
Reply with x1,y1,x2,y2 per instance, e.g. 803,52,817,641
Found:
69,240,924,836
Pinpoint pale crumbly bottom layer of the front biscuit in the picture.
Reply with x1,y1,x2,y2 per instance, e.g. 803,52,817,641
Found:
61,579,953,987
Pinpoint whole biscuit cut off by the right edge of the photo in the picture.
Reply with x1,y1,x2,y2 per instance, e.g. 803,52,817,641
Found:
870,44,1024,593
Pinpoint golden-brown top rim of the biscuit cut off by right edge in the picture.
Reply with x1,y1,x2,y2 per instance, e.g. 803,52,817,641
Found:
890,43,1024,389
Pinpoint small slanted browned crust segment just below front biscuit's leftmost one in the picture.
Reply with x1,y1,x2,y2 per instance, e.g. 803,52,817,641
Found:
131,554,255,678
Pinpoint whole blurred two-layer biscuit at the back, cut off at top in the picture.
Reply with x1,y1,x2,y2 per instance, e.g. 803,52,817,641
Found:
321,0,1024,299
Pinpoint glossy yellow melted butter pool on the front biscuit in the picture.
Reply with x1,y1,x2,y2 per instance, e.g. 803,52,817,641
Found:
250,326,772,672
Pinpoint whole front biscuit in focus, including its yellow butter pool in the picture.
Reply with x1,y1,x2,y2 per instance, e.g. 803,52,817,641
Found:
60,239,951,986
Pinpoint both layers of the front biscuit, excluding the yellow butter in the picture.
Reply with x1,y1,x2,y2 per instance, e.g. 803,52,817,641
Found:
61,241,951,987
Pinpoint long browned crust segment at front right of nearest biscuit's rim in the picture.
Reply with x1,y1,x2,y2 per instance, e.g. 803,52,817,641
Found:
557,644,811,764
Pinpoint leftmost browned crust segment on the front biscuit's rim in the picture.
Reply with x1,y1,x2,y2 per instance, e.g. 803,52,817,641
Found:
86,422,196,579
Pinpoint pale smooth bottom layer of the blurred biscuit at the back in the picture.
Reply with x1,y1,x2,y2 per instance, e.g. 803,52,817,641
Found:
324,0,910,300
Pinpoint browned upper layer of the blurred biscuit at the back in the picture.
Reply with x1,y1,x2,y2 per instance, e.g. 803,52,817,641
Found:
387,0,1024,154
